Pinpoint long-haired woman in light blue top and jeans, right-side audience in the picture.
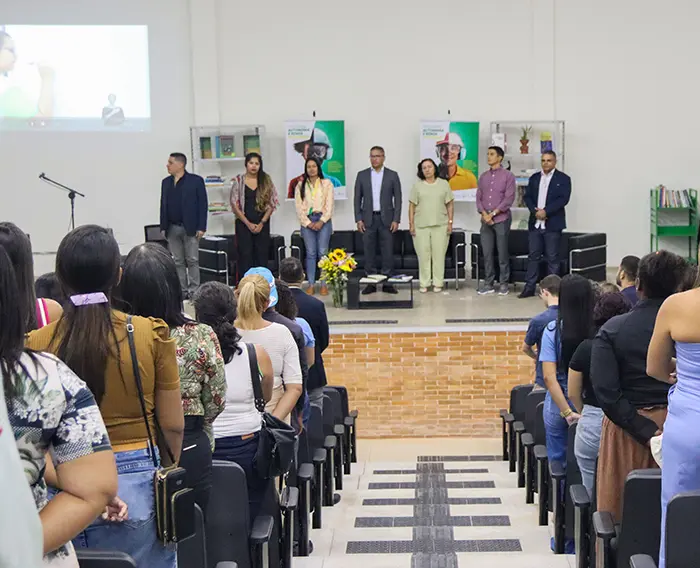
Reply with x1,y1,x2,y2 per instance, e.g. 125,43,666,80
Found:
540,274,595,467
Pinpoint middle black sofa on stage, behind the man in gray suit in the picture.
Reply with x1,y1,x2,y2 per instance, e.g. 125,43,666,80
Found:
291,230,466,287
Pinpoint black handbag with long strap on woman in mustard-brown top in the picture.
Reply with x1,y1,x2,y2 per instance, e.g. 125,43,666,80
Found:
126,316,195,544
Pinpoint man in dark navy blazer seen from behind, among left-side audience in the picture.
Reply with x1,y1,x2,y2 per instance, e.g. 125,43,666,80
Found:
280,256,329,408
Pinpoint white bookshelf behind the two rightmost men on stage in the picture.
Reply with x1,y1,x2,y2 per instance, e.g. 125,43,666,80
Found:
484,120,566,228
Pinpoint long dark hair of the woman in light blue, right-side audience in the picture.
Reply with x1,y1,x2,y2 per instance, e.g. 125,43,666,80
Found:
557,274,595,372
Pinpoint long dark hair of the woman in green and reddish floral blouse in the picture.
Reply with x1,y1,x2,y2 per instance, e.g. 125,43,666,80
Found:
115,243,187,328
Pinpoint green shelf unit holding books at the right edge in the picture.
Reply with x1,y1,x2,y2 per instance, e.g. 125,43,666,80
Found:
649,188,698,263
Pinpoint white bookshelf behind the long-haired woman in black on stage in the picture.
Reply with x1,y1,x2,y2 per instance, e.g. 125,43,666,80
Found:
190,125,266,235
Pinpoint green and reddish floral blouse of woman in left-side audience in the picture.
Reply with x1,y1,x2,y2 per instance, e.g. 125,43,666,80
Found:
170,322,226,449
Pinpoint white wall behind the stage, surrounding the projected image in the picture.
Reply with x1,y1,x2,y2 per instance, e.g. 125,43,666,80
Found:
12,0,700,270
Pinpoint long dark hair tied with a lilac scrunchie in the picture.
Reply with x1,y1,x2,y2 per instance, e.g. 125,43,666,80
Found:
51,225,120,404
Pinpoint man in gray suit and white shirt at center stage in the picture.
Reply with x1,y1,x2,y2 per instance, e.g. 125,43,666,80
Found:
355,146,401,294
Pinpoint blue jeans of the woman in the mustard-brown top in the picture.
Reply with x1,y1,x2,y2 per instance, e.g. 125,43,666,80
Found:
73,450,177,568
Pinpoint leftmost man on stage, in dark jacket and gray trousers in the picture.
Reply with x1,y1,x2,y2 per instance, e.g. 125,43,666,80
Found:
160,152,209,298
